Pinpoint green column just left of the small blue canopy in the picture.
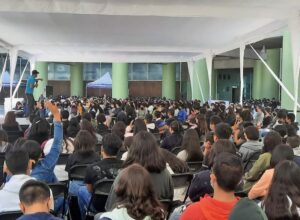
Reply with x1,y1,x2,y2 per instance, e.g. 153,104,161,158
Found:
70,63,83,96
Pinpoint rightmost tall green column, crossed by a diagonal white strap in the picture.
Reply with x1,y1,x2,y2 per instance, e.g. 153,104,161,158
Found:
281,32,294,110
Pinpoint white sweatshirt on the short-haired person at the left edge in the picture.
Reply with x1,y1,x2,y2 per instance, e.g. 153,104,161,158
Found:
0,174,34,212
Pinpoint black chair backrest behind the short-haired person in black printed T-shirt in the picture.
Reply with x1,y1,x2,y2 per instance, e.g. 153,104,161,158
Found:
91,179,114,212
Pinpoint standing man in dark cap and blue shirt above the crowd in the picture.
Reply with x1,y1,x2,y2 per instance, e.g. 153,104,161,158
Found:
25,70,39,116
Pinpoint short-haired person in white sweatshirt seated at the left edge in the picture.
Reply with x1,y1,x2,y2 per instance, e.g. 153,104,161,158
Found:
0,150,33,212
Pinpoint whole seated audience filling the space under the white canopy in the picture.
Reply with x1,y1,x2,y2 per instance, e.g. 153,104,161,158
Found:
0,97,300,220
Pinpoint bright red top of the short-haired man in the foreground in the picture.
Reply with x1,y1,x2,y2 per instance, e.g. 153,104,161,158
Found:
180,195,239,220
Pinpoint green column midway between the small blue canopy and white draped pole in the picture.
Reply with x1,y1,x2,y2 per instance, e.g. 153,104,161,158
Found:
162,63,176,99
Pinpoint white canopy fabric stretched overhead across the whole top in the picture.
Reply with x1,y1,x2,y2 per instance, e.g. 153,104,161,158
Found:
0,0,300,62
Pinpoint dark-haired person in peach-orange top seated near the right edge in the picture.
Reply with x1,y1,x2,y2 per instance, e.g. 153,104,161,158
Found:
248,144,294,199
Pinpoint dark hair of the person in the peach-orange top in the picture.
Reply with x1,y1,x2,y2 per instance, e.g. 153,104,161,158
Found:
270,144,294,168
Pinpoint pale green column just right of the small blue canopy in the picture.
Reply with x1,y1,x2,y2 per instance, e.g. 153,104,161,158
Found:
112,63,128,99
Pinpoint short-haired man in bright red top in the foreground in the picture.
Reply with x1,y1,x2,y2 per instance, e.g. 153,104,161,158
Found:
180,153,243,220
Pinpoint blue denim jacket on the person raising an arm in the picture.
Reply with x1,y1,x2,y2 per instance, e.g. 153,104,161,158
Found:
31,121,63,183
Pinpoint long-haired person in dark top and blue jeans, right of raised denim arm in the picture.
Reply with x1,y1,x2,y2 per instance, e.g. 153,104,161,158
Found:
65,130,100,195
